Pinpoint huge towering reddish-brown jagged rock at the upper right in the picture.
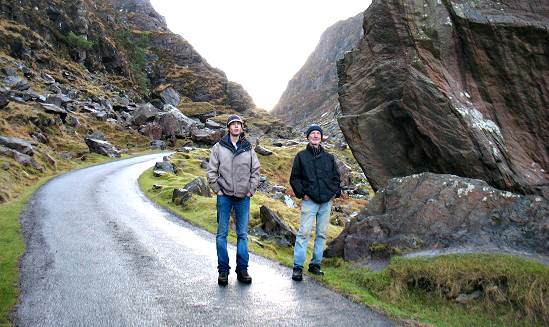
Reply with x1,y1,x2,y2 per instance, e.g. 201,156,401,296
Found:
338,0,549,197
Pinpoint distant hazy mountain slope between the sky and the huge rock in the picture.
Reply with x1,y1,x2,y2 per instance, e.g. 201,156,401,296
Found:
272,13,363,135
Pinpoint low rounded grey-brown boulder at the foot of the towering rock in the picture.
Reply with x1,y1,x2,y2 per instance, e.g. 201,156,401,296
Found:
326,173,549,260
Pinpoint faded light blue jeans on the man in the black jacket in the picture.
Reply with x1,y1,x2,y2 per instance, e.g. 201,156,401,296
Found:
294,200,332,269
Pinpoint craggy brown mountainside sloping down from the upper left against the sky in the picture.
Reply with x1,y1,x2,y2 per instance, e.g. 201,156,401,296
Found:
0,0,255,111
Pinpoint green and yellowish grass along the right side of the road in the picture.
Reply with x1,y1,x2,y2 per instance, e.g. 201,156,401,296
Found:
139,150,549,326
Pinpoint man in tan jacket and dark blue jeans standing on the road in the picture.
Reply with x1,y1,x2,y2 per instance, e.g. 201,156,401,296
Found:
208,115,259,286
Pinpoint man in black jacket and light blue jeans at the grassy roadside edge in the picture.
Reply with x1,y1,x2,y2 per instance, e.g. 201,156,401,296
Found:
290,124,341,281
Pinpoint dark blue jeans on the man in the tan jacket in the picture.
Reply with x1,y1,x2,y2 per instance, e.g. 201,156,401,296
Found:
215,195,250,272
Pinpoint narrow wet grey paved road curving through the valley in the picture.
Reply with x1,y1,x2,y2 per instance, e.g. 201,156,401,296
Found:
15,154,393,326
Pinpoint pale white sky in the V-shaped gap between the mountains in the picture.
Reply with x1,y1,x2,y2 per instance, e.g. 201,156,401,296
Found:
150,0,370,110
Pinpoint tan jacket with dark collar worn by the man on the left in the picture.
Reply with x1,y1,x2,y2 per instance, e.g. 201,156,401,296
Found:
208,135,259,198
